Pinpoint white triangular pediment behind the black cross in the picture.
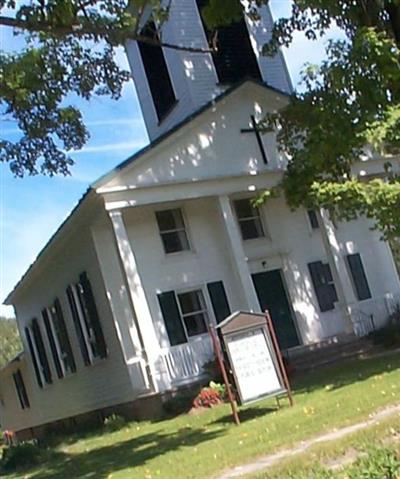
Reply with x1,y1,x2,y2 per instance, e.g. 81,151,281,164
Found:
94,81,287,192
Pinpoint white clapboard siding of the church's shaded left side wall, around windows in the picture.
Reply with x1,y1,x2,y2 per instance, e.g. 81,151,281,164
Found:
4,218,134,430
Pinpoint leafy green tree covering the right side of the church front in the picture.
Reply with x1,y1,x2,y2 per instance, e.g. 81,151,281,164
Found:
264,0,400,239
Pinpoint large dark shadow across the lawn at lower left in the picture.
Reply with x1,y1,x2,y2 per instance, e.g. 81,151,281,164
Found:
5,428,221,479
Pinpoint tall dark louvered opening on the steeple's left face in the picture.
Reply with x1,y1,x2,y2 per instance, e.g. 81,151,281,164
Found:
138,21,176,121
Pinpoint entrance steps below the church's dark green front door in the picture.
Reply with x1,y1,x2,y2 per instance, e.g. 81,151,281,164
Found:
285,335,384,373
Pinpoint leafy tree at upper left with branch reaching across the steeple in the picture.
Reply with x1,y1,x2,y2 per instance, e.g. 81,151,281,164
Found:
0,0,242,176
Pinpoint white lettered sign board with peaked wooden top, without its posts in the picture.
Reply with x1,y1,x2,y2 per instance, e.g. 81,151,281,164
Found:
217,312,288,404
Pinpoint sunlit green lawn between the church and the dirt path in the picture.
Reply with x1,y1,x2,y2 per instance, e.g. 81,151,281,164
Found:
7,355,400,479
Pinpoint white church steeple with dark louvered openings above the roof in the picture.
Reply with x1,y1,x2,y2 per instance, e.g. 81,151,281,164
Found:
126,0,291,141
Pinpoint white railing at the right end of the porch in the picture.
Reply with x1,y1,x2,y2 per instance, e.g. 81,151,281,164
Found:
349,293,400,337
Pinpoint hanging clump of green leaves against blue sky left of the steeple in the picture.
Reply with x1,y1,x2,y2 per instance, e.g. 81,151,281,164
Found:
0,37,129,176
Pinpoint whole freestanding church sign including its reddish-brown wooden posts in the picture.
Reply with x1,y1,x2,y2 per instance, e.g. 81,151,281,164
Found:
214,311,293,424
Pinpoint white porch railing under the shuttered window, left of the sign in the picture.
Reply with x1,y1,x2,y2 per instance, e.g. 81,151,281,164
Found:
161,334,214,383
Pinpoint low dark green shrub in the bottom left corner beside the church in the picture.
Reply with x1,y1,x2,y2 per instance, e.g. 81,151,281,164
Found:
0,441,46,472
